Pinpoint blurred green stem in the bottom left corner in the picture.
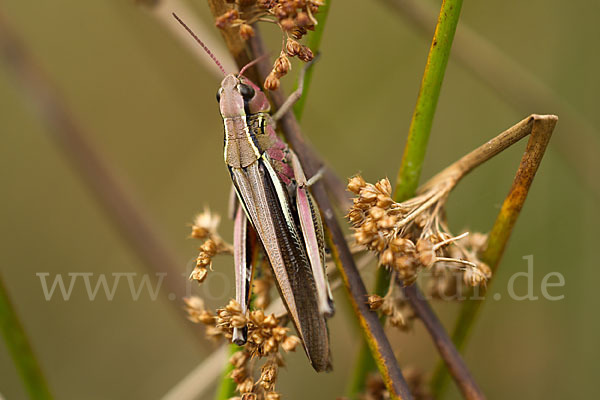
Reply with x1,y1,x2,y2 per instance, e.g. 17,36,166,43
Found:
0,276,52,399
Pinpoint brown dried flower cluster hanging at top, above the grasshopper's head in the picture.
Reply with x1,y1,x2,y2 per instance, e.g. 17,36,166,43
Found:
215,0,324,90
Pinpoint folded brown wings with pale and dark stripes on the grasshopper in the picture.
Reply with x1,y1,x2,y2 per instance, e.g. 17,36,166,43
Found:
229,154,331,371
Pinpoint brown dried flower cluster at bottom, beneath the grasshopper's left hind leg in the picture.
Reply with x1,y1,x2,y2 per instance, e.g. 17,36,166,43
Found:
185,297,300,400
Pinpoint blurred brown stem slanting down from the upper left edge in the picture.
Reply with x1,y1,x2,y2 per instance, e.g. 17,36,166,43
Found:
0,11,197,330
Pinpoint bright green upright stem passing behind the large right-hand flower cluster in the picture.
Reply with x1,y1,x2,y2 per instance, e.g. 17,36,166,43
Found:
350,0,462,396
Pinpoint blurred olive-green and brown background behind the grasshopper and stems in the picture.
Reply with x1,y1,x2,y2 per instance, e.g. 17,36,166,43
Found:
0,0,600,399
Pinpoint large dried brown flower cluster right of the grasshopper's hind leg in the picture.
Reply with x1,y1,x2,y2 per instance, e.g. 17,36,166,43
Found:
347,175,491,286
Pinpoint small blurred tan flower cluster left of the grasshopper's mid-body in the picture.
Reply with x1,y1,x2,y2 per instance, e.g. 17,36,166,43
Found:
190,208,233,283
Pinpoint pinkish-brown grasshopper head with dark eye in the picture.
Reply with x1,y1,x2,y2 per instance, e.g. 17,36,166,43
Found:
217,74,269,118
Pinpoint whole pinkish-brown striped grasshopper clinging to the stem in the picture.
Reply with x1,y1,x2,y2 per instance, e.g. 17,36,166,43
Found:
174,15,334,371
